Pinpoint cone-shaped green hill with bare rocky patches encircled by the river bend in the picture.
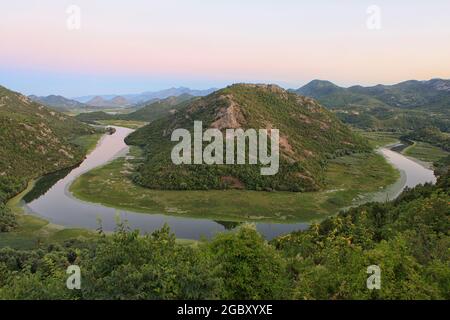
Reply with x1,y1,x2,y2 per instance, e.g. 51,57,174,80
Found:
126,84,369,191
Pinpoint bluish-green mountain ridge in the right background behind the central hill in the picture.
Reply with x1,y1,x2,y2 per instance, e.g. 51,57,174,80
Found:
291,79,450,131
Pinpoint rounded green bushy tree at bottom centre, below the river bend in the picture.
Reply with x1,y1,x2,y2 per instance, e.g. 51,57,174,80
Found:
207,226,290,300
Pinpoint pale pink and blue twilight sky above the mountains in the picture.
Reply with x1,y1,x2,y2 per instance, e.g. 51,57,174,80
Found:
0,0,450,97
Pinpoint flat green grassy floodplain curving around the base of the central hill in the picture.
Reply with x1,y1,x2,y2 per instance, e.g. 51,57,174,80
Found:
70,149,399,222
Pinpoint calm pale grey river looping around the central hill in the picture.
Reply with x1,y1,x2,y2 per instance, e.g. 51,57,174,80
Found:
23,127,435,239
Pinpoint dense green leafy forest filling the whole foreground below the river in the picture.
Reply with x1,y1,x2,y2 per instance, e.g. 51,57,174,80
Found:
0,173,450,299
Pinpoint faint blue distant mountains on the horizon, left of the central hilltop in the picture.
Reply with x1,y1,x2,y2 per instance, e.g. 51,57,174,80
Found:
74,87,217,104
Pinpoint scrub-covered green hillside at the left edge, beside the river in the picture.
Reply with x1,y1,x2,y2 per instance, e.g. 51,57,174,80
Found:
0,86,94,203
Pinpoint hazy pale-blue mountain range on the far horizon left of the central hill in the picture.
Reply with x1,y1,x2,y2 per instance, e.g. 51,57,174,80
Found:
73,87,217,107
